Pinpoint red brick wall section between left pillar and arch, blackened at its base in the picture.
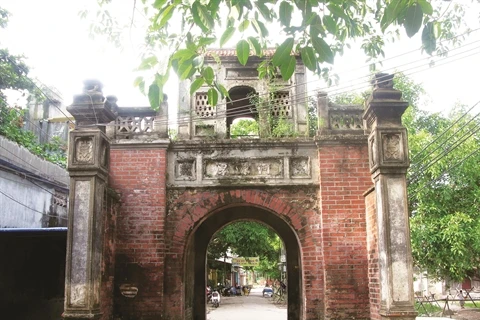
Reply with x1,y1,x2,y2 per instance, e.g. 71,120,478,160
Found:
110,147,166,319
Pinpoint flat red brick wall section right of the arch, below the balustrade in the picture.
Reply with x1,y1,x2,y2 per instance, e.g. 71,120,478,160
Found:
319,145,372,319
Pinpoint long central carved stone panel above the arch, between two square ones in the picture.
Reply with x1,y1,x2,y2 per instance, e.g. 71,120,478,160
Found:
203,158,283,179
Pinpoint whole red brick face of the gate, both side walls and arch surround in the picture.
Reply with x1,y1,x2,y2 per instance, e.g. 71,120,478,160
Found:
111,145,375,319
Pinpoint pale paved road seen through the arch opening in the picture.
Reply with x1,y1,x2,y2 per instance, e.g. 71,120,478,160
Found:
207,288,287,320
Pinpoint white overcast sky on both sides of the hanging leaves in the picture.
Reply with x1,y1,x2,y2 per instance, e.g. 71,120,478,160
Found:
0,0,480,111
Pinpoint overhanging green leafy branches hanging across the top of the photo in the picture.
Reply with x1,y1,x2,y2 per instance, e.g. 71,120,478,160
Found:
86,0,468,108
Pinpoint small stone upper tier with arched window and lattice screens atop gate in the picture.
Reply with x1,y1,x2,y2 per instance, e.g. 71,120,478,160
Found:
178,49,308,140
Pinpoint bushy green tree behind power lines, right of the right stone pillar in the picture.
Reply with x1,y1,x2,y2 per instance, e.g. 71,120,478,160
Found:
334,74,480,281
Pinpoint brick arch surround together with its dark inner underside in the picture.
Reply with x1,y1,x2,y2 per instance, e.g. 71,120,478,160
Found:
164,186,316,320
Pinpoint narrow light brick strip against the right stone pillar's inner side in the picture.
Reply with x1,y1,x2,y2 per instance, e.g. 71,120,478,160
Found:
365,188,381,320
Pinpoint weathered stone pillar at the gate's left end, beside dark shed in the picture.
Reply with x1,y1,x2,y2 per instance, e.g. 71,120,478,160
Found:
63,81,115,319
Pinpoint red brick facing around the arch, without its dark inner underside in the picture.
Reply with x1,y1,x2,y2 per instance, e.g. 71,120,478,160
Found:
164,187,316,319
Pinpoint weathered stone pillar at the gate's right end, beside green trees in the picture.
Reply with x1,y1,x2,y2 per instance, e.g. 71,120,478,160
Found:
363,74,417,320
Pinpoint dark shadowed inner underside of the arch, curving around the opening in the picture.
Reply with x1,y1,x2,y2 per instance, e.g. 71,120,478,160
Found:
184,206,303,320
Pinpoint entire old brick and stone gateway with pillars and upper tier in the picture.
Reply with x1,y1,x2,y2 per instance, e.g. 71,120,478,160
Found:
63,52,415,320
